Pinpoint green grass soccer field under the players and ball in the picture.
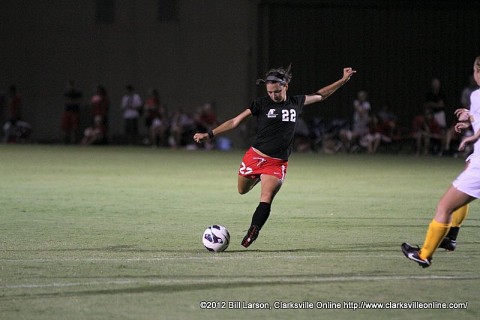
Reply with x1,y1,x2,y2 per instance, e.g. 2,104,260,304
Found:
0,145,480,320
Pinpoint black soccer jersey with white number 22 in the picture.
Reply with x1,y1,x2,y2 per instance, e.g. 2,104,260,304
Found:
250,95,305,160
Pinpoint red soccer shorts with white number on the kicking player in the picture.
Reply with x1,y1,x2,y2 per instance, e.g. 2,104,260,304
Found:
238,148,288,181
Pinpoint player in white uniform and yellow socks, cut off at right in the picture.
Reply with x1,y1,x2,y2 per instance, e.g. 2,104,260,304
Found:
401,56,480,268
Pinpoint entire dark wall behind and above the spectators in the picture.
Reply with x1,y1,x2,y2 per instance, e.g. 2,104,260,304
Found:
0,0,480,142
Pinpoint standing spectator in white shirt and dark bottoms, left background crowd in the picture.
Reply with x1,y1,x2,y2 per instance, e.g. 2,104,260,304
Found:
121,85,143,144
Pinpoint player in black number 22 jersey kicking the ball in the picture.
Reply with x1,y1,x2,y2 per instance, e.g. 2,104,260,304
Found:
193,65,356,248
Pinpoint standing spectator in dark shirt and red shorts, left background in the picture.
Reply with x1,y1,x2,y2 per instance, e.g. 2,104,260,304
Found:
61,80,83,144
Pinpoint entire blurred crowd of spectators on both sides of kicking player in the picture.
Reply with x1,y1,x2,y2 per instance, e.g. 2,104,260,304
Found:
0,78,476,156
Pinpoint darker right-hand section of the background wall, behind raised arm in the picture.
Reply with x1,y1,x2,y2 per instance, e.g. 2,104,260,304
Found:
258,0,480,127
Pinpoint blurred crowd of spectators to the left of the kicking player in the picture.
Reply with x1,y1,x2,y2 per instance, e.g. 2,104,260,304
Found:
0,81,227,149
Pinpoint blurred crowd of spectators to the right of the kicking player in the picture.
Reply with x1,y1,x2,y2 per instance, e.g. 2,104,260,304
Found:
295,77,477,157
